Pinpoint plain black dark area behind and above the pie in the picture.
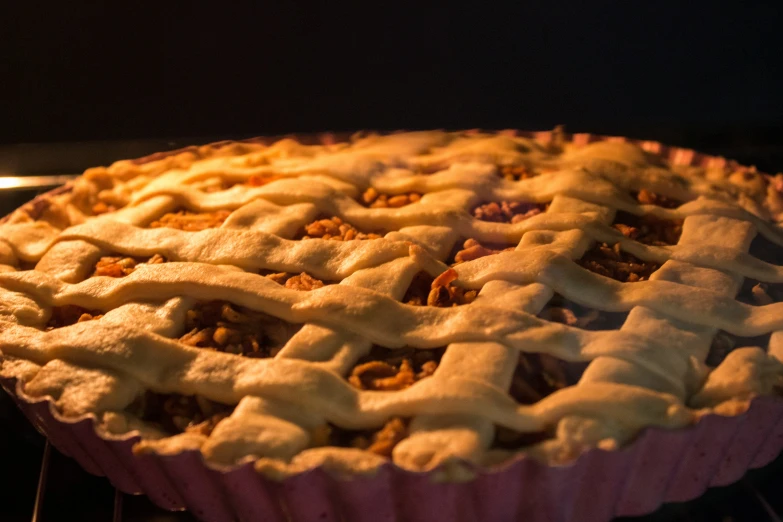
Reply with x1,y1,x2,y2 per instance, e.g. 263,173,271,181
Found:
0,0,783,145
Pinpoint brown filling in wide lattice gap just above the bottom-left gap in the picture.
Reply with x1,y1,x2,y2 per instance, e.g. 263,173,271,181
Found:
179,301,301,358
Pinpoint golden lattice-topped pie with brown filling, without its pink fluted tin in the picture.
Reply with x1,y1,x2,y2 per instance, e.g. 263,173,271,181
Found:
0,132,783,476
